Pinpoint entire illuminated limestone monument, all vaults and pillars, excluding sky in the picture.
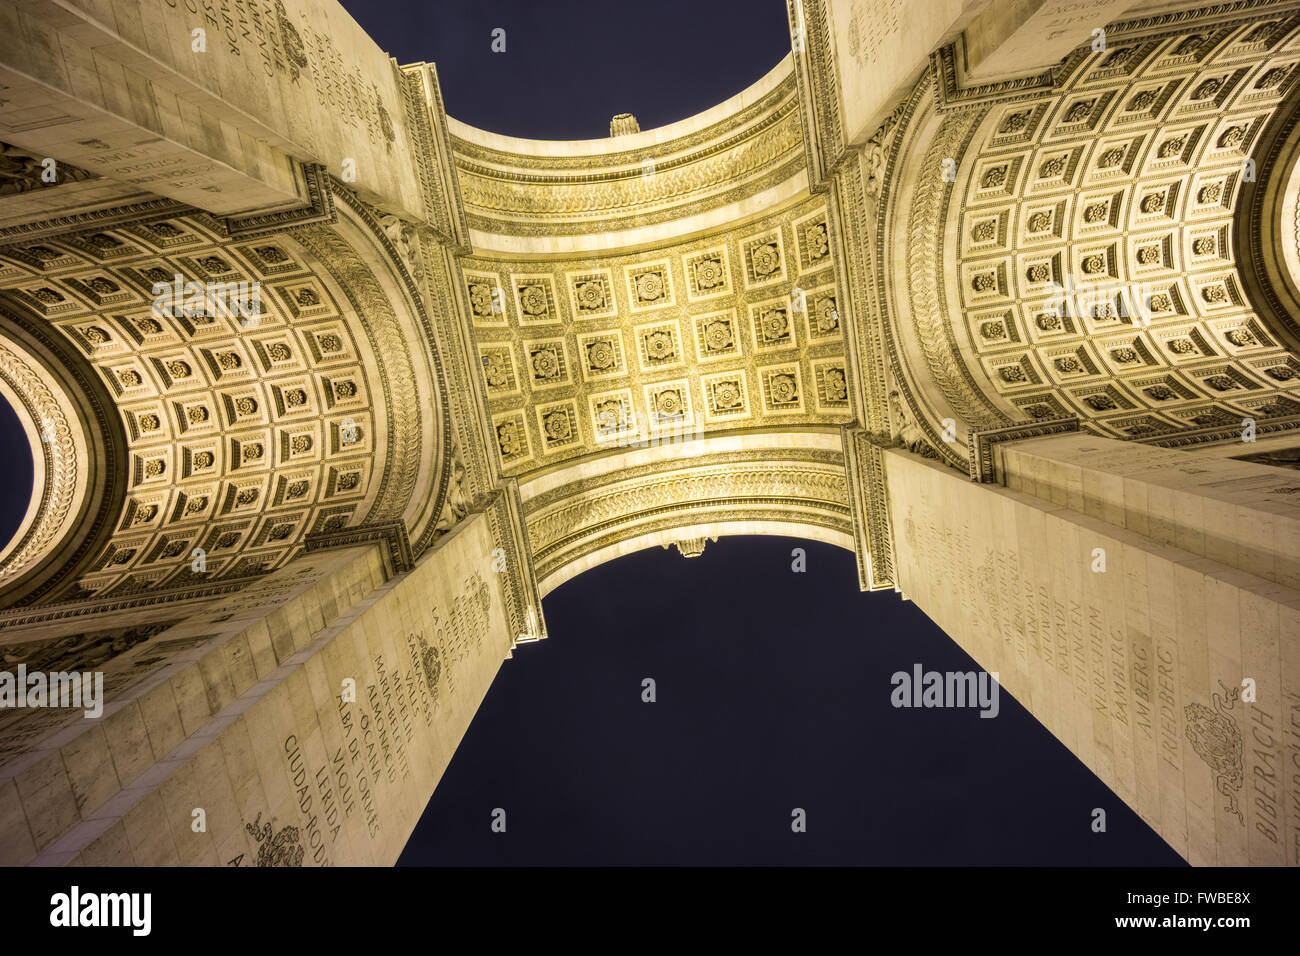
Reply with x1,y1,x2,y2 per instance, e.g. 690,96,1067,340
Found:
0,0,1300,865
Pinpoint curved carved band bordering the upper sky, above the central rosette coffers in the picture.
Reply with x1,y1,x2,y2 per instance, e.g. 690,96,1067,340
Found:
447,55,807,258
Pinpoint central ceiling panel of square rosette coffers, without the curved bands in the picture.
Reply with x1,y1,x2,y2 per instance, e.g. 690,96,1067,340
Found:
462,198,852,475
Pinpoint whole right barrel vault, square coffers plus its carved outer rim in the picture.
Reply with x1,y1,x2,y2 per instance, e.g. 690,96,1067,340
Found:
884,21,1300,450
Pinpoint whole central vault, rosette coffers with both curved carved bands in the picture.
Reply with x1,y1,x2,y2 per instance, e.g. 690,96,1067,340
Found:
449,56,853,594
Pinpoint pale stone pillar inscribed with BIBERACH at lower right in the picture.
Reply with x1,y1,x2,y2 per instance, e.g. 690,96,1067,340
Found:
881,433,1300,865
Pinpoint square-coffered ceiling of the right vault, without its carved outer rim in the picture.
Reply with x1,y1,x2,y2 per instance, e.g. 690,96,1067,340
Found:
949,21,1300,438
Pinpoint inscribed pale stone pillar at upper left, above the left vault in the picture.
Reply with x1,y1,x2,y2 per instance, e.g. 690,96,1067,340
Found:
0,0,432,220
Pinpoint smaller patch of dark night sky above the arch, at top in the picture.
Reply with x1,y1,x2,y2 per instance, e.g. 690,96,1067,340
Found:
343,0,790,139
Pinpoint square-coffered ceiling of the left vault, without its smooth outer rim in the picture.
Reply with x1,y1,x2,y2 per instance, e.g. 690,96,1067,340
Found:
0,215,384,598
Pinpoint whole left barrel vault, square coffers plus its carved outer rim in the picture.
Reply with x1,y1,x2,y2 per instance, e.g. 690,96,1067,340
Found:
0,198,450,604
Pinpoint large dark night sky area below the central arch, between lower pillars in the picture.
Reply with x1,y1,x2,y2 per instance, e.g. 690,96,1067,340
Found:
400,537,1182,865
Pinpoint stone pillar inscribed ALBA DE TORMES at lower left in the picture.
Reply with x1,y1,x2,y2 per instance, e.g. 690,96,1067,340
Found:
0,514,519,866
